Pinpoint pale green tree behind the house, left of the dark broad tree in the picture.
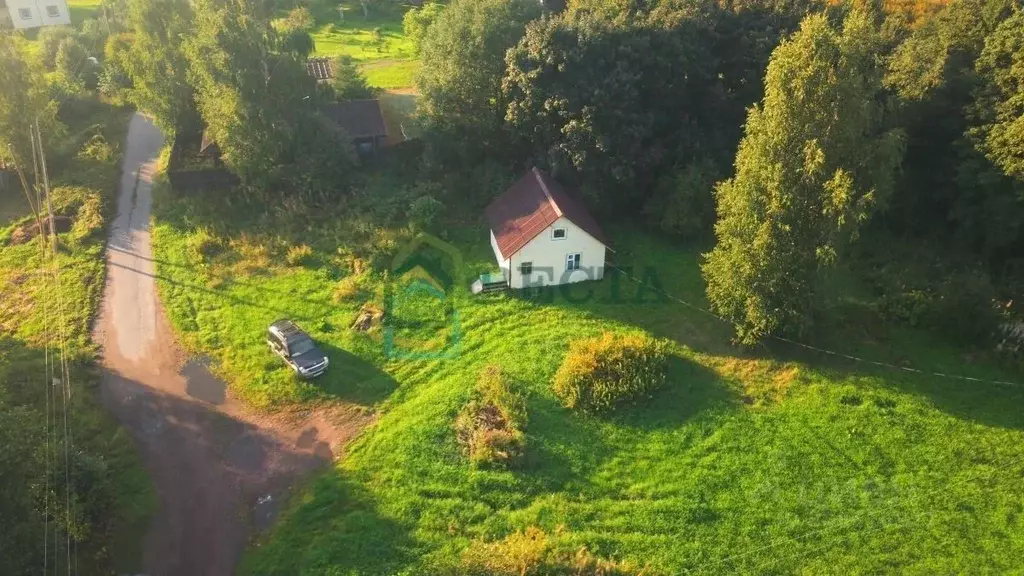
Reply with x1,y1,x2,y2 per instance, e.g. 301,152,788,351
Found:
417,0,541,157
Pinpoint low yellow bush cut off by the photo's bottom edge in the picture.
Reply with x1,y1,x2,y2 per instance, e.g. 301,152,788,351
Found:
456,527,647,576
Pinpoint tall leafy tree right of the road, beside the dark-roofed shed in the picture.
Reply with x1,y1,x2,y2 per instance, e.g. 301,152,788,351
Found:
184,0,353,198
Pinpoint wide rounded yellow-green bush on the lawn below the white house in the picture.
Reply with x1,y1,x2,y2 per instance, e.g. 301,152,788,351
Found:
553,332,669,412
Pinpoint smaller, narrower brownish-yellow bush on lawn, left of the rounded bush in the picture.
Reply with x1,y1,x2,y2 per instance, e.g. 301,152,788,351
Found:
455,366,526,465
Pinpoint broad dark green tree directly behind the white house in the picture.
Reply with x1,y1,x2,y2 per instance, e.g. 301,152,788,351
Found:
503,0,811,213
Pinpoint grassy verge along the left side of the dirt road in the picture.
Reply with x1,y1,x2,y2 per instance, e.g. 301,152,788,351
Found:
0,100,156,573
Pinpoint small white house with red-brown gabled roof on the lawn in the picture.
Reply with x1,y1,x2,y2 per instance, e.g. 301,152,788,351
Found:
484,168,606,288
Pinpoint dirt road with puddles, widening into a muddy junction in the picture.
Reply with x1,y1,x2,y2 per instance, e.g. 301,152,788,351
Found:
93,114,369,576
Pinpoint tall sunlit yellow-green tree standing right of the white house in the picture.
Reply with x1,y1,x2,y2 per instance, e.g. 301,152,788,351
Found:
702,11,902,343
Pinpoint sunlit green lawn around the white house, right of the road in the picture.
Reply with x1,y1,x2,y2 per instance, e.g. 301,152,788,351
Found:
149,191,1024,574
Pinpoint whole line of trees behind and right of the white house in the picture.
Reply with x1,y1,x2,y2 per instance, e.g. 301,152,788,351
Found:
418,0,1024,343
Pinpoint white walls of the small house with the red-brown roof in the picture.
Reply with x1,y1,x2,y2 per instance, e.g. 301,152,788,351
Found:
499,216,605,288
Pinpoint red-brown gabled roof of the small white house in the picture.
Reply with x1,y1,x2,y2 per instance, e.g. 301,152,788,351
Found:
484,167,605,258
